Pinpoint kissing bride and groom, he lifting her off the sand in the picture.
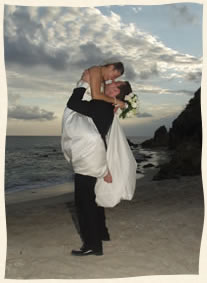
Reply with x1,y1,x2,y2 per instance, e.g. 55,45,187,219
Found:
61,62,137,256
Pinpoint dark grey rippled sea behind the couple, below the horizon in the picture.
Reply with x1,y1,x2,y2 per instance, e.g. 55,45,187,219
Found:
5,136,147,193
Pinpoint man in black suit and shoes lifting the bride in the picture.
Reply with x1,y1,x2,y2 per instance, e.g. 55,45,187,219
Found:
63,73,132,256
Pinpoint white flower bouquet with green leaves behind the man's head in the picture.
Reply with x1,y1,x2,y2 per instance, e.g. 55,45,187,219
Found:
119,93,138,119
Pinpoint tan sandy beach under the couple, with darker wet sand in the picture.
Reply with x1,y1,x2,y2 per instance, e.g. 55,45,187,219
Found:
5,169,204,279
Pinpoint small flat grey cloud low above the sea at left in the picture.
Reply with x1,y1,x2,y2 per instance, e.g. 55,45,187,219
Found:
8,105,56,121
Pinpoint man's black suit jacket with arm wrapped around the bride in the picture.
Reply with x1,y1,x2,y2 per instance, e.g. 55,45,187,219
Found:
67,87,114,149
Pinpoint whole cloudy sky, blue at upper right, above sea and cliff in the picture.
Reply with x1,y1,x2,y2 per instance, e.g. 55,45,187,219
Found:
4,3,203,136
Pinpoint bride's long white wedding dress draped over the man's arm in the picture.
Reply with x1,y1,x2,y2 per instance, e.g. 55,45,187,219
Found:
61,91,137,207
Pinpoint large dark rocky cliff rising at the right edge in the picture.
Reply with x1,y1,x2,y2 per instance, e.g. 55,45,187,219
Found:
142,89,202,180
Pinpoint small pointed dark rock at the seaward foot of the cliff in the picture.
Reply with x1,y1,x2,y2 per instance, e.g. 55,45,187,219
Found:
141,126,169,147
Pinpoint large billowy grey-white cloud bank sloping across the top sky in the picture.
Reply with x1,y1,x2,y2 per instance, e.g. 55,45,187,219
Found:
5,6,201,82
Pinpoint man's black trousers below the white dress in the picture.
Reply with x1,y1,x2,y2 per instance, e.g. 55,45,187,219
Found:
75,174,108,251
